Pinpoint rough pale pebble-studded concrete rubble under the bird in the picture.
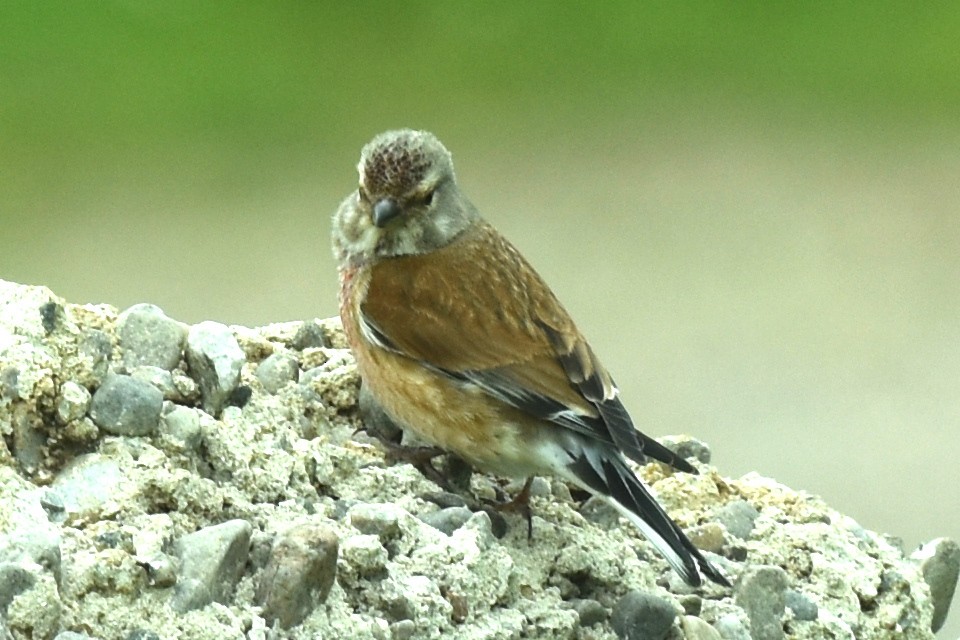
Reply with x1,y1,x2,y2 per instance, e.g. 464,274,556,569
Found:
0,281,960,640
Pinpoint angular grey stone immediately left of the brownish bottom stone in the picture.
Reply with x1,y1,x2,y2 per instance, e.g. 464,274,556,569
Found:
171,520,253,613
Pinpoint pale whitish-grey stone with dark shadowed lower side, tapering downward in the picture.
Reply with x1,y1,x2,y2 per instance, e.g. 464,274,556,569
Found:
187,320,246,416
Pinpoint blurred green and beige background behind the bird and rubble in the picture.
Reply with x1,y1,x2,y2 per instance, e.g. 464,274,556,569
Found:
0,1,960,637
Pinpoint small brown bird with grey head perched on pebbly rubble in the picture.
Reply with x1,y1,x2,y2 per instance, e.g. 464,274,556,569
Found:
332,129,730,586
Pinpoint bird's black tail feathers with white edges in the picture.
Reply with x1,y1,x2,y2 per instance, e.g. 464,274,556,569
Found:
567,443,731,587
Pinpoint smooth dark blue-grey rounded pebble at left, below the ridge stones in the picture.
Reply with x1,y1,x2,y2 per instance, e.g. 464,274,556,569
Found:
90,374,163,436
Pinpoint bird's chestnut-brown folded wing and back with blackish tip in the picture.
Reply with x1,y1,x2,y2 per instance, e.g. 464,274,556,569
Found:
361,224,693,471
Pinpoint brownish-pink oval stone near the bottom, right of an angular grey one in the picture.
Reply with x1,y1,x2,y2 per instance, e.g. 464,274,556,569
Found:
256,522,339,629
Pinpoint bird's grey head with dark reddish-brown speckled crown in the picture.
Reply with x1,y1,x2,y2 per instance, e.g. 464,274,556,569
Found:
333,129,478,263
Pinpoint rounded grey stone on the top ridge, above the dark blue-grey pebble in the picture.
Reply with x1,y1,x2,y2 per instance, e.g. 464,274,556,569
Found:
117,304,187,371
